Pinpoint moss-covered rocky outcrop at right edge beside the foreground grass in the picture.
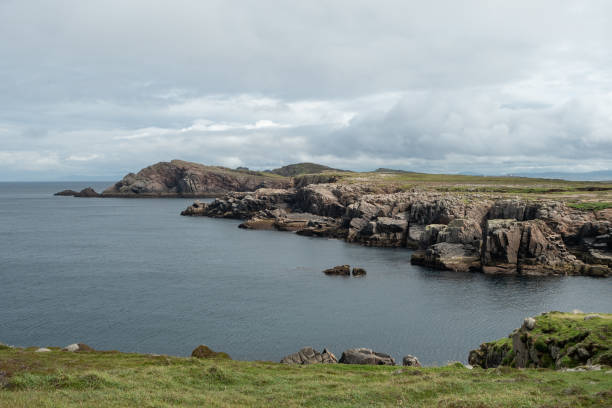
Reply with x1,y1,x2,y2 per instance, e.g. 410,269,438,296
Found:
468,312,612,368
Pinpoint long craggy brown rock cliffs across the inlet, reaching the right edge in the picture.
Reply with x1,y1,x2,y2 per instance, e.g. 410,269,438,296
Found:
182,183,612,276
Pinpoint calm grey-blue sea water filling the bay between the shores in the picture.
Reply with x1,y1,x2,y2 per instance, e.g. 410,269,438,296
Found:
0,182,612,364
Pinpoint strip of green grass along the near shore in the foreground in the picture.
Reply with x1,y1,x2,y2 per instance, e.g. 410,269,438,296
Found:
0,348,612,407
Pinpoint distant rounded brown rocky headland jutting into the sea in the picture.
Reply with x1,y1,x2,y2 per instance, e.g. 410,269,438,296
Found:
102,160,292,197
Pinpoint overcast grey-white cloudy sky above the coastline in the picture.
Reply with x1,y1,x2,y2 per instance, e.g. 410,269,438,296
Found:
0,0,612,181
